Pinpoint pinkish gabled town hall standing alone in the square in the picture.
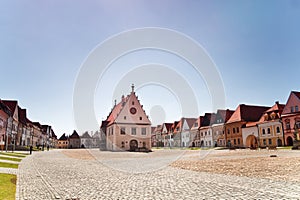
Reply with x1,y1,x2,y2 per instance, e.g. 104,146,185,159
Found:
101,85,151,151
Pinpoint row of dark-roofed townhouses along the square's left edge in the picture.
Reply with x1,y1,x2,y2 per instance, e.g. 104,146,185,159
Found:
0,99,57,150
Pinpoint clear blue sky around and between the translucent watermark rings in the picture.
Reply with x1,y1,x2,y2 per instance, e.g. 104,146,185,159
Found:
0,0,300,135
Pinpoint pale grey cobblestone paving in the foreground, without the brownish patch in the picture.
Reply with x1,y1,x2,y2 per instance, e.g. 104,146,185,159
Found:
16,150,300,199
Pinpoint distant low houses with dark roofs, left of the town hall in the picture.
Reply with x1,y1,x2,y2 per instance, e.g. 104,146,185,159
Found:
57,130,100,149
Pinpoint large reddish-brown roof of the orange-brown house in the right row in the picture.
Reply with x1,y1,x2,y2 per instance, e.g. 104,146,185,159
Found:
227,104,270,123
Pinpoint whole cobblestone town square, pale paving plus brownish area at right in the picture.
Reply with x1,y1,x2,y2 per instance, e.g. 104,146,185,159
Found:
16,149,300,199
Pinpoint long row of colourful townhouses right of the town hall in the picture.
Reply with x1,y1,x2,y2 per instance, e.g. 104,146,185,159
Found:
151,91,300,148
